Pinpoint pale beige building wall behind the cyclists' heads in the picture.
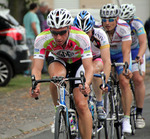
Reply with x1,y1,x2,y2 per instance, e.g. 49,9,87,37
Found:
39,0,150,23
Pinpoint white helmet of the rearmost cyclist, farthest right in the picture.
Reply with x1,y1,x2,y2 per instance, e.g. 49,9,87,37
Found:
119,4,136,20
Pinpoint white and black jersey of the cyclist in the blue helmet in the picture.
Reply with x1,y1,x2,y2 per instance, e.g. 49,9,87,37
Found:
90,28,110,58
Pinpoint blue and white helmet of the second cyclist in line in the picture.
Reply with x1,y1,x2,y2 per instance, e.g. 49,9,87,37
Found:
73,10,95,32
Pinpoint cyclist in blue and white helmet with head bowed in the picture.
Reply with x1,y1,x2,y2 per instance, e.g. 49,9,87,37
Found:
74,10,111,120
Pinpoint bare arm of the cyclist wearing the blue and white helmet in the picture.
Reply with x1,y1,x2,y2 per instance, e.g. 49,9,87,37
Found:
100,48,111,83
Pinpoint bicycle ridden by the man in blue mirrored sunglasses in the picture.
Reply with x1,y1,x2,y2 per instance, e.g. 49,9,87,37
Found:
105,61,128,139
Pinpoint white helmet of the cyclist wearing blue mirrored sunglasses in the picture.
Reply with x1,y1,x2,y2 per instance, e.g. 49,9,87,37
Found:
100,4,120,18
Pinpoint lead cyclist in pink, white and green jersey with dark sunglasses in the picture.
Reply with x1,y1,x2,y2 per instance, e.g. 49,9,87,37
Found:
30,9,93,139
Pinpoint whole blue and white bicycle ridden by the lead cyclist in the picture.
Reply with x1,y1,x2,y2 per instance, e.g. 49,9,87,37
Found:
31,72,87,139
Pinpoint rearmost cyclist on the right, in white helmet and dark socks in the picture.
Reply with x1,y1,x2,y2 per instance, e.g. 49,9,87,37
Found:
120,4,147,128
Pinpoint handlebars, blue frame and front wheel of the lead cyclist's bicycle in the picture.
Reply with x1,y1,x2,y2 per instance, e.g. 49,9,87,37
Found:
31,72,85,139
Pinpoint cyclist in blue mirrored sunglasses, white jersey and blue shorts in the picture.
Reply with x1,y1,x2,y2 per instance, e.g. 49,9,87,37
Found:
100,4,132,133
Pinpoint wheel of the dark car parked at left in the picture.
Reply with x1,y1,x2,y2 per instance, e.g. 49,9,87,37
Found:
0,57,13,86
